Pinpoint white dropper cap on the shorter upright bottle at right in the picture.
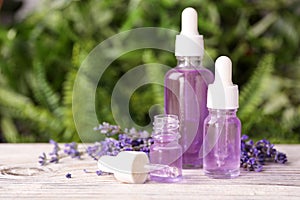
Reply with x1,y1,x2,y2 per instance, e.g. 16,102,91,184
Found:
207,56,239,110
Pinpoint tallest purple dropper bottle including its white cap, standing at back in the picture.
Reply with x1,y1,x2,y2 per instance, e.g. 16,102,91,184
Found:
165,7,214,168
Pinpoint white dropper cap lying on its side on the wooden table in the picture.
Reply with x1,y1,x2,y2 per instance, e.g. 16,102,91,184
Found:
98,151,149,183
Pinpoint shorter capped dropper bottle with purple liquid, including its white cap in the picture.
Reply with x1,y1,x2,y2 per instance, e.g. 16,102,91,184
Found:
203,56,241,178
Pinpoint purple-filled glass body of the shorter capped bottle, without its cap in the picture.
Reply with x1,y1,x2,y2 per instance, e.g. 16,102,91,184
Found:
203,109,241,178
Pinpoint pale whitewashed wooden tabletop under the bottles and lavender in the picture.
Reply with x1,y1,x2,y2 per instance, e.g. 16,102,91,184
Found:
0,144,300,200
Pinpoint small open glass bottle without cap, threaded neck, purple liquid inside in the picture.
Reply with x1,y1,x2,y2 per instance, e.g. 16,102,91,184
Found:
149,114,182,182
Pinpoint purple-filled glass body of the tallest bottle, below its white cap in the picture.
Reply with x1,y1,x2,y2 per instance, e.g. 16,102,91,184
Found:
165,57,214,168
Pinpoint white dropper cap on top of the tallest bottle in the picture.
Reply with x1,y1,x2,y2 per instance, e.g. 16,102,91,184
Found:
175,7,204,57
